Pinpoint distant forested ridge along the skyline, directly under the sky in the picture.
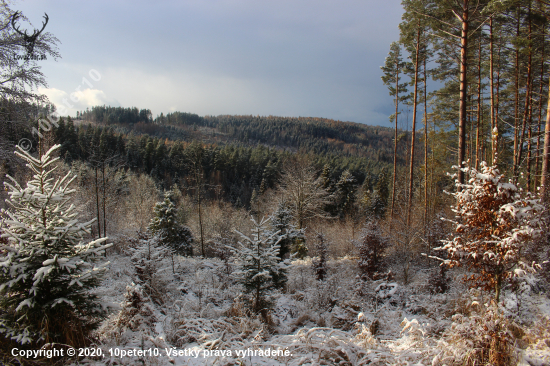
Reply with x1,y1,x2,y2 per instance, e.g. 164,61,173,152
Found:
77,106,405,163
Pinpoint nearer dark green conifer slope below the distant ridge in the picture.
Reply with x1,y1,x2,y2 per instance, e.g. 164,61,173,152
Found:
12,113,396,215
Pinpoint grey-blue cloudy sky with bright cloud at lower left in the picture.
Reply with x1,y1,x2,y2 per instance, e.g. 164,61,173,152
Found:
16,0,402,126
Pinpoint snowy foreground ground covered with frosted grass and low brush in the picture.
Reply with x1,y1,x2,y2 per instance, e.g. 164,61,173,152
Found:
77,247,550,366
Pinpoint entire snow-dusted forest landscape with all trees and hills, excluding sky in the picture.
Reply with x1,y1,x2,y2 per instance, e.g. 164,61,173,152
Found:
0,0,550,366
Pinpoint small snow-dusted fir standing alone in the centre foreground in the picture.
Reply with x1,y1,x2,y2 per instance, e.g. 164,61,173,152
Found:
231,218,288,319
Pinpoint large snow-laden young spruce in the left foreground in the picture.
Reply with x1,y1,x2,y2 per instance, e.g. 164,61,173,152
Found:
0,145,110,346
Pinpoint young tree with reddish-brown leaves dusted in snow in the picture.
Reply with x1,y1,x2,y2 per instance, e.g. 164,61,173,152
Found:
436,162,544,303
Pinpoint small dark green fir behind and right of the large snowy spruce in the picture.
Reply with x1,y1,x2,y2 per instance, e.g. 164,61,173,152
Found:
149,191,193,255
